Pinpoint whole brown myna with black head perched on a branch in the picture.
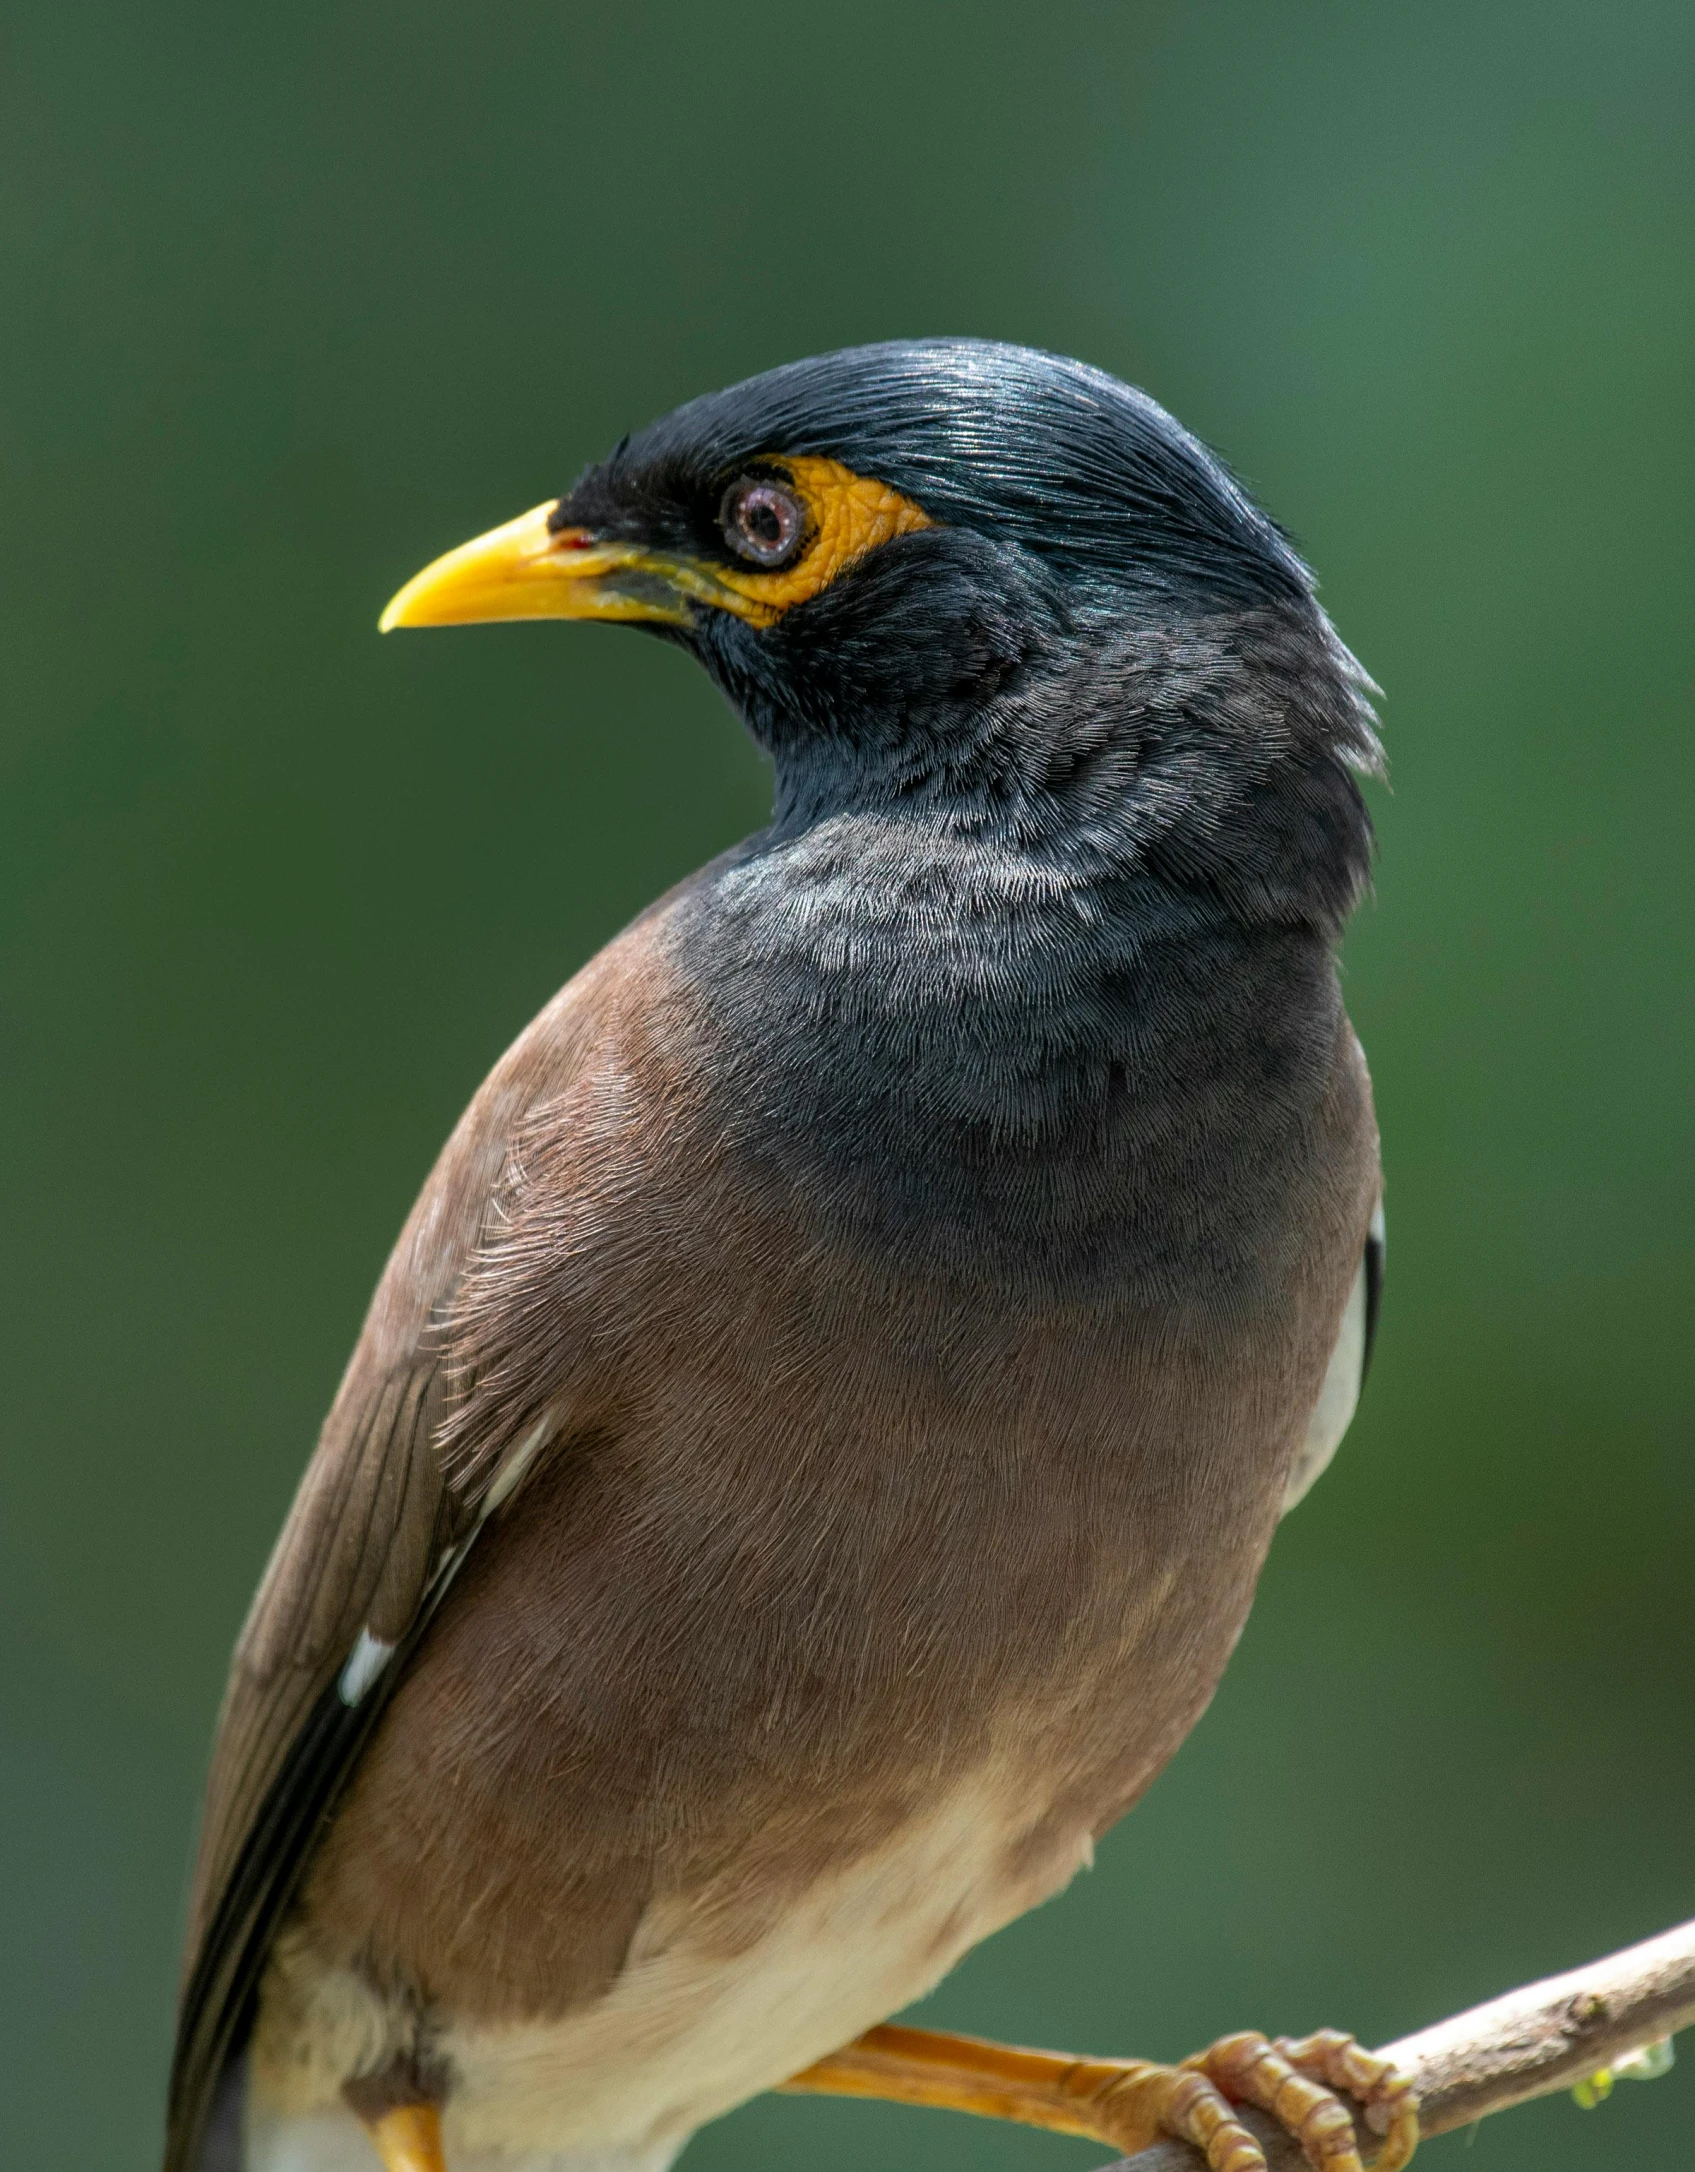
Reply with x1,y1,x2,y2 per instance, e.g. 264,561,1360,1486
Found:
163,339,1417,2172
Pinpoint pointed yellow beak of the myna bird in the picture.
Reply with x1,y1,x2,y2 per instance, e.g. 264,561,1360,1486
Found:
376,504,699,634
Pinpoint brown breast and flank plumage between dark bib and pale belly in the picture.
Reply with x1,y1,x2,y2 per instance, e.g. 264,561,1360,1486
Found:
291,942,1376,2018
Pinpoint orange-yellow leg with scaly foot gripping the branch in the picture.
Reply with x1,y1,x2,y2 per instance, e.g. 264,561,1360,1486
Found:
784,2026,1419,2172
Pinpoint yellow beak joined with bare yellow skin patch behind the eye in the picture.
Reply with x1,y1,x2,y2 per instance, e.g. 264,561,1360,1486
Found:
378,454,934,634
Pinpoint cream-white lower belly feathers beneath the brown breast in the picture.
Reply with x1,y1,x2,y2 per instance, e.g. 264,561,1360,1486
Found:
246,1772,1091,2172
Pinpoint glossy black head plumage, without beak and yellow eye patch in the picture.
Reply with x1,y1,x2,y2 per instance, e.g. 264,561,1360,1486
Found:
554,339,1378,927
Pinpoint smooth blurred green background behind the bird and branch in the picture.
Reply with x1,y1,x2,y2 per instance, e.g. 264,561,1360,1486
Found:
0,0,1695,2172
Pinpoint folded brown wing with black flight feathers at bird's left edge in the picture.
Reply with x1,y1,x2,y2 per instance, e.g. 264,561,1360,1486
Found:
165,973,611,2172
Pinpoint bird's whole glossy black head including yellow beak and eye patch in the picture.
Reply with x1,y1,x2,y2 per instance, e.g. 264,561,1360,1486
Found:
382,339,1376,916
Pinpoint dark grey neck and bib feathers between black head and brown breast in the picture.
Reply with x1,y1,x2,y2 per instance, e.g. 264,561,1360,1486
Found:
678,610,1376,1281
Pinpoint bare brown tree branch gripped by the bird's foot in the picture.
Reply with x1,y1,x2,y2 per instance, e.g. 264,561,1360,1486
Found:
1110,1922,1695,2172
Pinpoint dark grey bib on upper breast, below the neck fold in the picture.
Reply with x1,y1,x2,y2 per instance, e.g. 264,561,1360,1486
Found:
671,817,1345,1281
